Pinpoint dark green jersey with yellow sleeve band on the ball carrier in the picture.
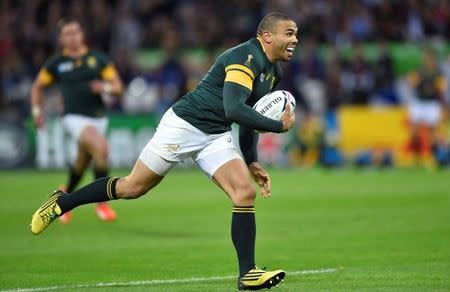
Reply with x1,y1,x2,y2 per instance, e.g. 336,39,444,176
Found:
172,38,281,134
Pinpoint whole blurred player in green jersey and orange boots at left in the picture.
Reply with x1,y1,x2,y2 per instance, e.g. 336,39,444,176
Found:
31,19,123,223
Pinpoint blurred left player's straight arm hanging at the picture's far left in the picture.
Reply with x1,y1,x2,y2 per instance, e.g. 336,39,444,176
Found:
31,67,55,128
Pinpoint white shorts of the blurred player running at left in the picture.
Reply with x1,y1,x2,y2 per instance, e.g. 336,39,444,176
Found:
62,114,108,141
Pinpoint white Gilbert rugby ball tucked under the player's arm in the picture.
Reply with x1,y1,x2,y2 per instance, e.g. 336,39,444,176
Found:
253,90,296,121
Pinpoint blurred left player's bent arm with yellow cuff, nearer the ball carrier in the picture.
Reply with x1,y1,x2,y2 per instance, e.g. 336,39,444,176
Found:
90,64,123,96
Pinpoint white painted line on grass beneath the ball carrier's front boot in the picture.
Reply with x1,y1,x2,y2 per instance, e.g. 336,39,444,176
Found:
0,268,338,292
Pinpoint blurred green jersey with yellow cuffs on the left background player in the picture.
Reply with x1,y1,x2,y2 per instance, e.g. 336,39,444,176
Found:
38,48,117,117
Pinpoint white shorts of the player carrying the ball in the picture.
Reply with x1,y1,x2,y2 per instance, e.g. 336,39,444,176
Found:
139,108,242,178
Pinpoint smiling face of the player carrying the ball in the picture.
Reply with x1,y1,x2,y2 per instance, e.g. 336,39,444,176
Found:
272,20,298,61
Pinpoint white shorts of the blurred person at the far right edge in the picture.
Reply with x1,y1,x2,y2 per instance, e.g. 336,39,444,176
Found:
408,101,441,126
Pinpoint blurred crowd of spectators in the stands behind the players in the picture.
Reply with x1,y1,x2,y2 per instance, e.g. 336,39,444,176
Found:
0,0,450,168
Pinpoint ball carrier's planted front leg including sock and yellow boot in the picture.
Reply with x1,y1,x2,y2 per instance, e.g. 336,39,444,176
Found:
213,159,285,290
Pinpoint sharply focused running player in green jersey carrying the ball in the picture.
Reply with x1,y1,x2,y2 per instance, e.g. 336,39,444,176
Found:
31,13,298,290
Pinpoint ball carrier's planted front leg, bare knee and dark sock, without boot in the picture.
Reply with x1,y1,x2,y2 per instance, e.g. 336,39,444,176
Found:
213,159,256,277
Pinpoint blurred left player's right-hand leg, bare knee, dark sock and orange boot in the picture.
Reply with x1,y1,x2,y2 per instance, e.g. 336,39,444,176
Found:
79,126,116,221
